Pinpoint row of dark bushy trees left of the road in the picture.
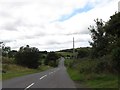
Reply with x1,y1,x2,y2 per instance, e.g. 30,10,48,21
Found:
2,45,60,69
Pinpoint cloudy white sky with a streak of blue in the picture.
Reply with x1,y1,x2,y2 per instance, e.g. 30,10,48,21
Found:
0,0,119,51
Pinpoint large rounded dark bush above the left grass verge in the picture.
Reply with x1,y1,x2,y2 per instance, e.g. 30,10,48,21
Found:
15,45,40,68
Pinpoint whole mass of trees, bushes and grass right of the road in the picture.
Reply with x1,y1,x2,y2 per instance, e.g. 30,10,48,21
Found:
65,12,120,90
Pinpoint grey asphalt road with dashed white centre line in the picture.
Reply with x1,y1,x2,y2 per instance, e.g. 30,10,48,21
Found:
2,58,75,90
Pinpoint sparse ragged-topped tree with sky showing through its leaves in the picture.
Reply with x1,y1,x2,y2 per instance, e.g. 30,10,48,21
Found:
88,19,108,57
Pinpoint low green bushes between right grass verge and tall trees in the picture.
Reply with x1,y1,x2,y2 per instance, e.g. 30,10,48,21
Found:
72,55,113,74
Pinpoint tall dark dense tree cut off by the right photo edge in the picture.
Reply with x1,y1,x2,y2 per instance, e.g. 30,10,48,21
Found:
105,12,120,72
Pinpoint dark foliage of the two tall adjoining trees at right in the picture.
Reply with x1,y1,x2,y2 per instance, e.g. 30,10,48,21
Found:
89,12,120,72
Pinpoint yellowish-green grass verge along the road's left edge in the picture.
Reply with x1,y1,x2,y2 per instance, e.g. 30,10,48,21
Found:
2,64,51,80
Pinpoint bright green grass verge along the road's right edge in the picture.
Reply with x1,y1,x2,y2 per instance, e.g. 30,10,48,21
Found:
67,68,118,88
